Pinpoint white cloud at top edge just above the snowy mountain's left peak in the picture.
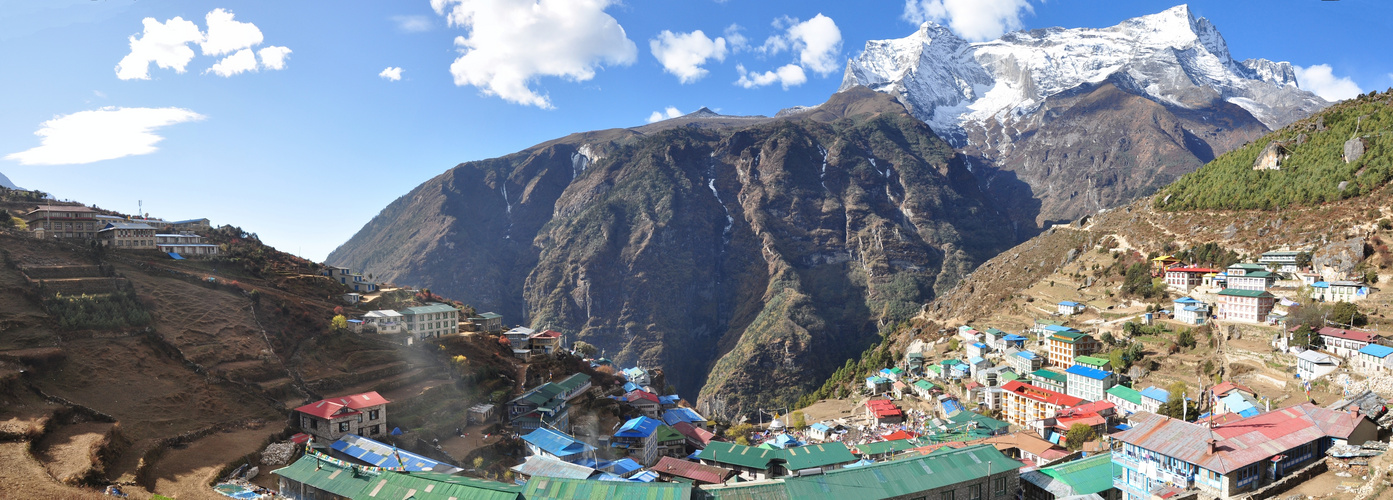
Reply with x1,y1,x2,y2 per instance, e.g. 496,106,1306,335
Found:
903,0,1035,42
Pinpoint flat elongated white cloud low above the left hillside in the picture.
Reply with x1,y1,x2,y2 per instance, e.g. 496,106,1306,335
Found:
4,106,205,164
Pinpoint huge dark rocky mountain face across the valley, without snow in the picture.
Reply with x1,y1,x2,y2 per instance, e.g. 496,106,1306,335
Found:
329,89,1015,415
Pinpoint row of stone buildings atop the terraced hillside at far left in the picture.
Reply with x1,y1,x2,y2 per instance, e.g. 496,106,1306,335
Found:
22,205,217,259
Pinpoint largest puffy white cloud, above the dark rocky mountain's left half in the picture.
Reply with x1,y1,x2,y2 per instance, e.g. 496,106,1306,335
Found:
430,0,638,109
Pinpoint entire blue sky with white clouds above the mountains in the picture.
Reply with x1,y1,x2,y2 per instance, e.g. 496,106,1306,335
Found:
0,0,1393,260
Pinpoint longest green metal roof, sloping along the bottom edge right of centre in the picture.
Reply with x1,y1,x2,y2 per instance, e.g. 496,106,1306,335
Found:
698,444,1014,500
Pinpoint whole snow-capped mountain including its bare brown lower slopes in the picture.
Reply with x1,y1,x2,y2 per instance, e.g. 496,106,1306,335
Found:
841,6,1329,229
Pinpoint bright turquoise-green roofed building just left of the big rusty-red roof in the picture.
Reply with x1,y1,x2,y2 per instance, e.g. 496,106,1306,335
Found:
1021,453,1121,500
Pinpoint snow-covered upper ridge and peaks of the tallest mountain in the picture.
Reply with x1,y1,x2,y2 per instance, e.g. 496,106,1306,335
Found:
841,6,1328,145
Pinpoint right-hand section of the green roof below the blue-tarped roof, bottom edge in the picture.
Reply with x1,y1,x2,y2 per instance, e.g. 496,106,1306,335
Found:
354,472,522,500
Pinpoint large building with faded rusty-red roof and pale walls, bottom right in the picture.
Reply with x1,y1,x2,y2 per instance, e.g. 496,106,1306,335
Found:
1112,404,1378,500
